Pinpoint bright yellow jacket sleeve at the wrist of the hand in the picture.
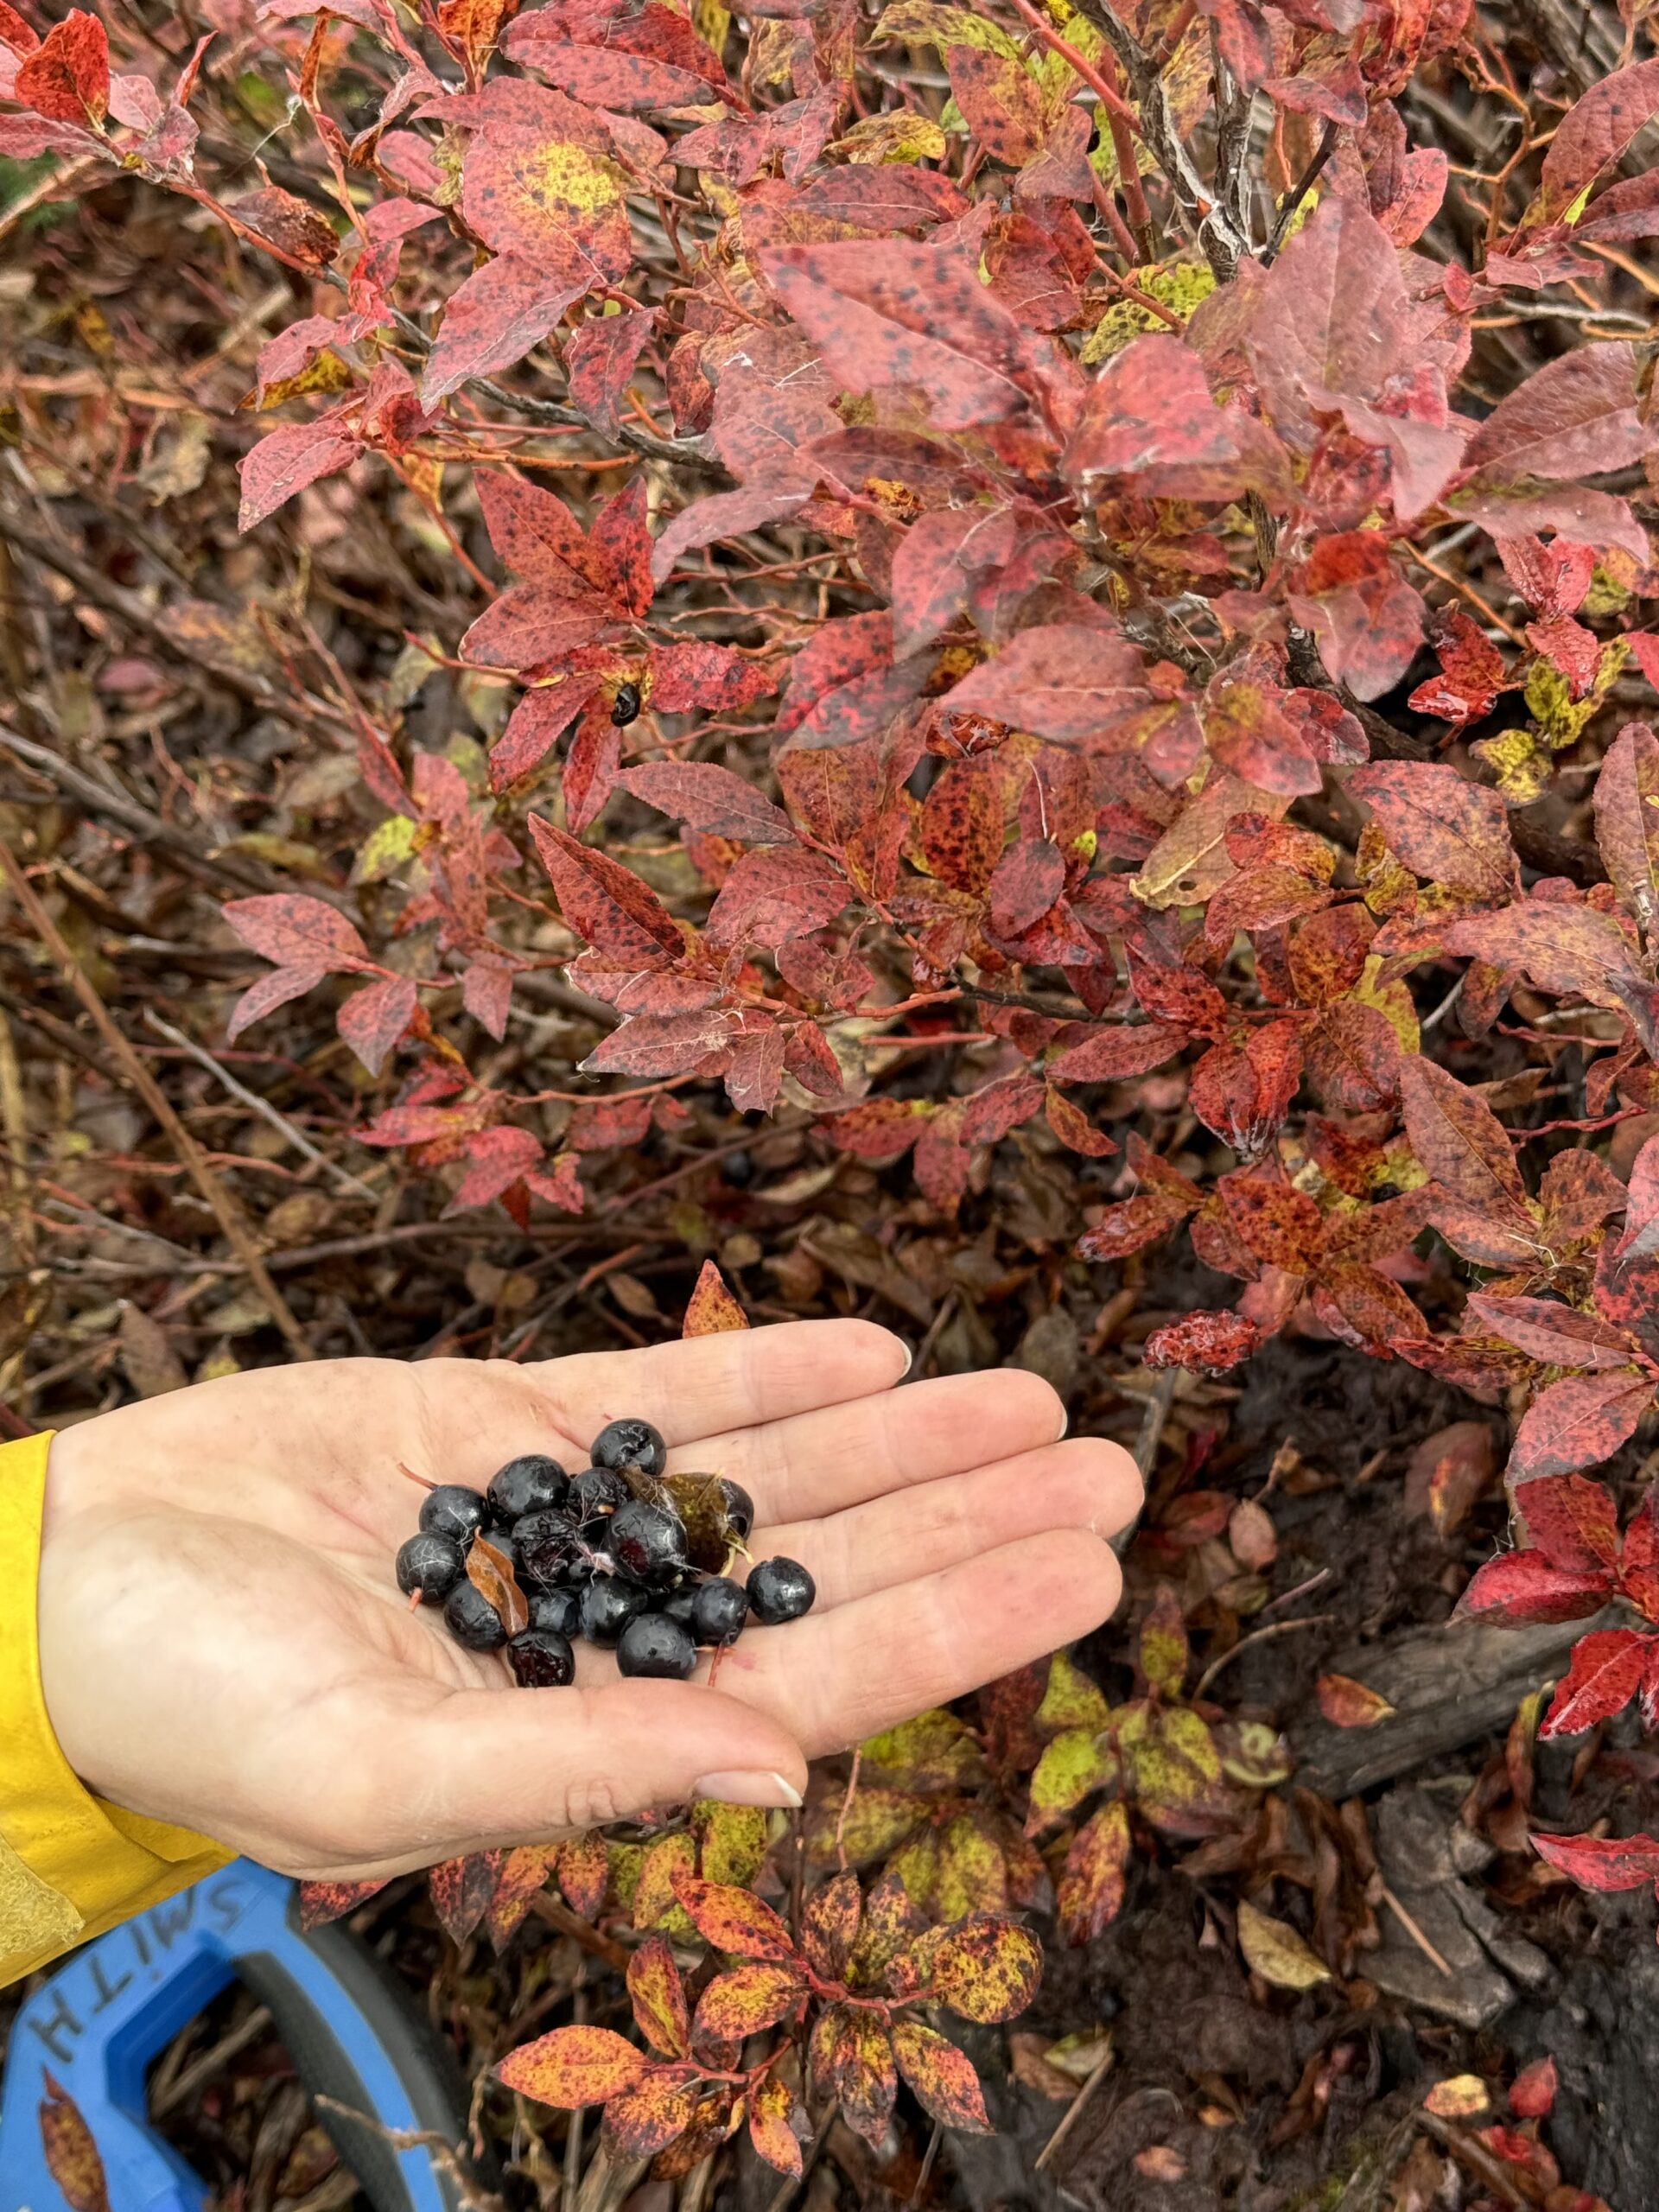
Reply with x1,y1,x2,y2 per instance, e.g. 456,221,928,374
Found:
0,1435,232,1986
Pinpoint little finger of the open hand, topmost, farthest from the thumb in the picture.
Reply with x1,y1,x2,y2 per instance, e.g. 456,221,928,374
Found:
410,1320,909,1489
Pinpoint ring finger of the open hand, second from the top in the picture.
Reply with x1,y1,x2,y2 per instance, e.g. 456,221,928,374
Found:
668,1367,1066,1522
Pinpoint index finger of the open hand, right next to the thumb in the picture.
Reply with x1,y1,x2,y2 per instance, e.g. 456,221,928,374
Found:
681,1529,1123,1758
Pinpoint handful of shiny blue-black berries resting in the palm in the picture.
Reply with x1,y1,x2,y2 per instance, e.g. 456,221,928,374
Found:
396,1421,817,1690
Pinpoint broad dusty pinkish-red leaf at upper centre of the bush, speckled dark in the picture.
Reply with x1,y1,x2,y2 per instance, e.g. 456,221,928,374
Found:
761,238,1027,429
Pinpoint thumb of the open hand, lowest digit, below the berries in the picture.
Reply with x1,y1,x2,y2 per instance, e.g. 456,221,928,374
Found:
393,1681,807,1849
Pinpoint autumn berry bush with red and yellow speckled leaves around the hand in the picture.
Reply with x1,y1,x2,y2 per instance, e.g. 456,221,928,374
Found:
0,0,1659,2201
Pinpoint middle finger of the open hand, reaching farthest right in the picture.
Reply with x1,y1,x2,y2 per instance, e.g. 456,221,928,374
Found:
750,1435,1144,1608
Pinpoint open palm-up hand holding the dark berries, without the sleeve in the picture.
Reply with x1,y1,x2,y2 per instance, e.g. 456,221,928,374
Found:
40,1320,1141,1880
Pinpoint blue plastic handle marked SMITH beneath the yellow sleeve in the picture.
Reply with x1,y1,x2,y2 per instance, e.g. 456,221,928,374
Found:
0,1858,465,2212
